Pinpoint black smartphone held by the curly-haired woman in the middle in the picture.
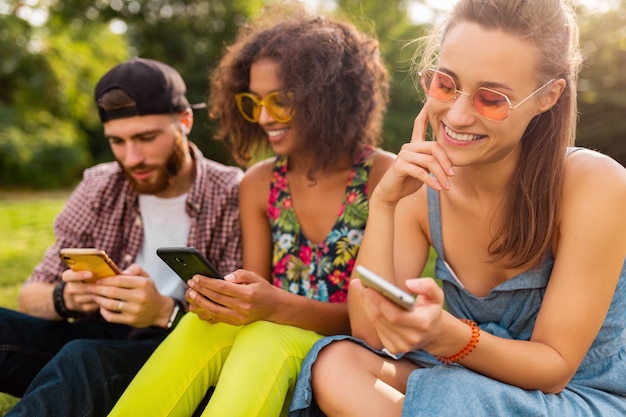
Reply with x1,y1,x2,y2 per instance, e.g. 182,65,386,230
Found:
157,247,224,283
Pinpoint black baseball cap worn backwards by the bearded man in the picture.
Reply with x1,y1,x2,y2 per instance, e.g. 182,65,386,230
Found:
95,58,204,123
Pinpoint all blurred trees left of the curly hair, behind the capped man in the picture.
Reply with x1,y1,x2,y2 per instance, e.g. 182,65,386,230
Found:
0,0,263,188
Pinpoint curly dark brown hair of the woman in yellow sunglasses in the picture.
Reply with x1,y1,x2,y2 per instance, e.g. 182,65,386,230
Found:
209,1,389,172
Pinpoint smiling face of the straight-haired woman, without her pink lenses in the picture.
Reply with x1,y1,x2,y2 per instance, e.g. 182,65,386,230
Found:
428,22,550,166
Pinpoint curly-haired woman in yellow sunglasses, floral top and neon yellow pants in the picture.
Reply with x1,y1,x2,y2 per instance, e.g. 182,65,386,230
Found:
106,2,394,417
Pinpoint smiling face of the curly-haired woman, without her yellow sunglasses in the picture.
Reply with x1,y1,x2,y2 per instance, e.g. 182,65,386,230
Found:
249,58,296,155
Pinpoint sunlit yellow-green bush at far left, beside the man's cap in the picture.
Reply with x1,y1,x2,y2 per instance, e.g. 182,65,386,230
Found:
0,2,127,187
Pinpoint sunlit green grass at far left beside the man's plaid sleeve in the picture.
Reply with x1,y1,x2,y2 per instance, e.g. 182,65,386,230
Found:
0,192,69,416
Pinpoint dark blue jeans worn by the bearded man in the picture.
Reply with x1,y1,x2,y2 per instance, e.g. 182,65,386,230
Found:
0,308,167,417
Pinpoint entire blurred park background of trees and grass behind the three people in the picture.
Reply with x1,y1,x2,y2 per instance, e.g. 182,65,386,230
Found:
0,0,626,416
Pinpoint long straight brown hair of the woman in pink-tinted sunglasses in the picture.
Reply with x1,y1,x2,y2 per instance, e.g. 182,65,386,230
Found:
415,0,581,268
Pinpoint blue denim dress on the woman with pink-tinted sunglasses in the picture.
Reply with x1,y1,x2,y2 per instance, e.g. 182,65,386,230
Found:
289,189,626,417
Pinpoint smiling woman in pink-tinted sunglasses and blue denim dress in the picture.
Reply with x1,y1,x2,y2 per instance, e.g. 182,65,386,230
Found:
290,0,626,417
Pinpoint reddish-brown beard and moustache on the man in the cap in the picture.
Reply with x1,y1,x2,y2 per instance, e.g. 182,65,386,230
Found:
117,134,185,194
